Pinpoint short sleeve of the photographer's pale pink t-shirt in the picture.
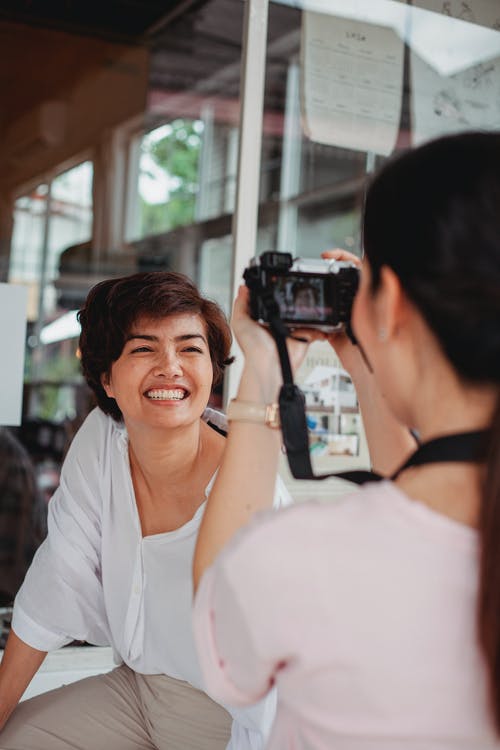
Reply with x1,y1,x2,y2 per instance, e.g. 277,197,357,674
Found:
193,508,302,706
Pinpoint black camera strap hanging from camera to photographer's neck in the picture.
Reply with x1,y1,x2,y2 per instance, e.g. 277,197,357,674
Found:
260,287,489,484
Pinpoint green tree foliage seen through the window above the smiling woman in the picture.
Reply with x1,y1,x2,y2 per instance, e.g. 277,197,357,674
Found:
141,120,201,236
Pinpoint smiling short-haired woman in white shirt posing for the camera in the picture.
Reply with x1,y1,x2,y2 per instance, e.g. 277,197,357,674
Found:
0,272,288,750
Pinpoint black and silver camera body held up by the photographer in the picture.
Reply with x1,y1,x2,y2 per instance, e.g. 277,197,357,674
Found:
243,251,359,333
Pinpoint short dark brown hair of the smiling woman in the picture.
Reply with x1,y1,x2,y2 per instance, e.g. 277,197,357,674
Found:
78,271,232,421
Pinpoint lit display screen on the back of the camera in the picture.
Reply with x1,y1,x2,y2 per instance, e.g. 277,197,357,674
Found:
274,275,333,323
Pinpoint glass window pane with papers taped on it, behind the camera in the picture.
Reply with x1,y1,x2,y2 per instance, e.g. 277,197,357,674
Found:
258,0,500,478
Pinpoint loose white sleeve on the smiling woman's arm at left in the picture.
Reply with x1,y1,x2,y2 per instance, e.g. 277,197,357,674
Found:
12,412,109,651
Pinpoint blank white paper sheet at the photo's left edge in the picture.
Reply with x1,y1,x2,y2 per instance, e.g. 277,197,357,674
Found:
0,284,28,426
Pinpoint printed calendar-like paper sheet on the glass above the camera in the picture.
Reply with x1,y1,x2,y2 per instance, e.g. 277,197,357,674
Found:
301,11,404,155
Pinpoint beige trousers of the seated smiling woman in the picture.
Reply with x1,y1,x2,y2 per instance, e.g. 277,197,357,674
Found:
0,665,232,750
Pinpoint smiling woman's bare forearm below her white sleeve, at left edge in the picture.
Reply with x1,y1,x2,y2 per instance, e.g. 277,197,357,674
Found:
0,630,47,731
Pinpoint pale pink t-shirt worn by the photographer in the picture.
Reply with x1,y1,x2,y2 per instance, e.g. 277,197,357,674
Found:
194,482,500,750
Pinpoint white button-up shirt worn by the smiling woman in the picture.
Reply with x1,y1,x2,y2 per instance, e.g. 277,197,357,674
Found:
12,409,290,750
